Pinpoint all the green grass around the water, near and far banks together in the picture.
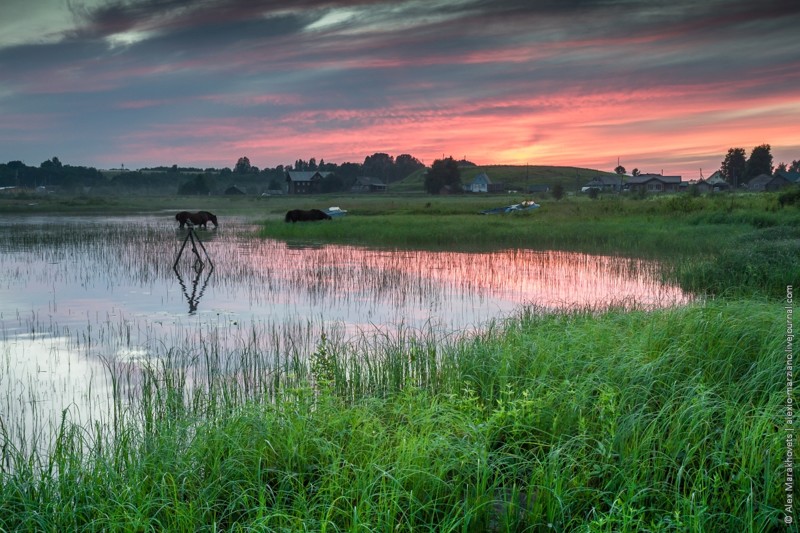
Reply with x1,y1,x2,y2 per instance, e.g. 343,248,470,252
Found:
0,189,800,532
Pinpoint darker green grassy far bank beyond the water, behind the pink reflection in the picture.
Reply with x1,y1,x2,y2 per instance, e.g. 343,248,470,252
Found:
260,194,800,298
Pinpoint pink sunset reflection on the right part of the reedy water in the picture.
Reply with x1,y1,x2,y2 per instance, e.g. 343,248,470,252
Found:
234,241,691,321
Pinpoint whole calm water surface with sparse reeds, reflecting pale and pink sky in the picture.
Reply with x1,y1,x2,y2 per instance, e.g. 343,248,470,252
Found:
0,214,688,446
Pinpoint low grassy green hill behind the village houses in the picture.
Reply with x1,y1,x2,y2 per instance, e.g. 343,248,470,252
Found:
389,165,613,193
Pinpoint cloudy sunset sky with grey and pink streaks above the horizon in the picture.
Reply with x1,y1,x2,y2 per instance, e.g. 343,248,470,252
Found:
0,0,800,179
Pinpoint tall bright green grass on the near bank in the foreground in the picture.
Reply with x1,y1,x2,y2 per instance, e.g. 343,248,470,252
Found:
0,300,786,531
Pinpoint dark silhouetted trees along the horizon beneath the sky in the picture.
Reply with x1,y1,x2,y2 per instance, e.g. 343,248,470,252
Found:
0,144,800,195
